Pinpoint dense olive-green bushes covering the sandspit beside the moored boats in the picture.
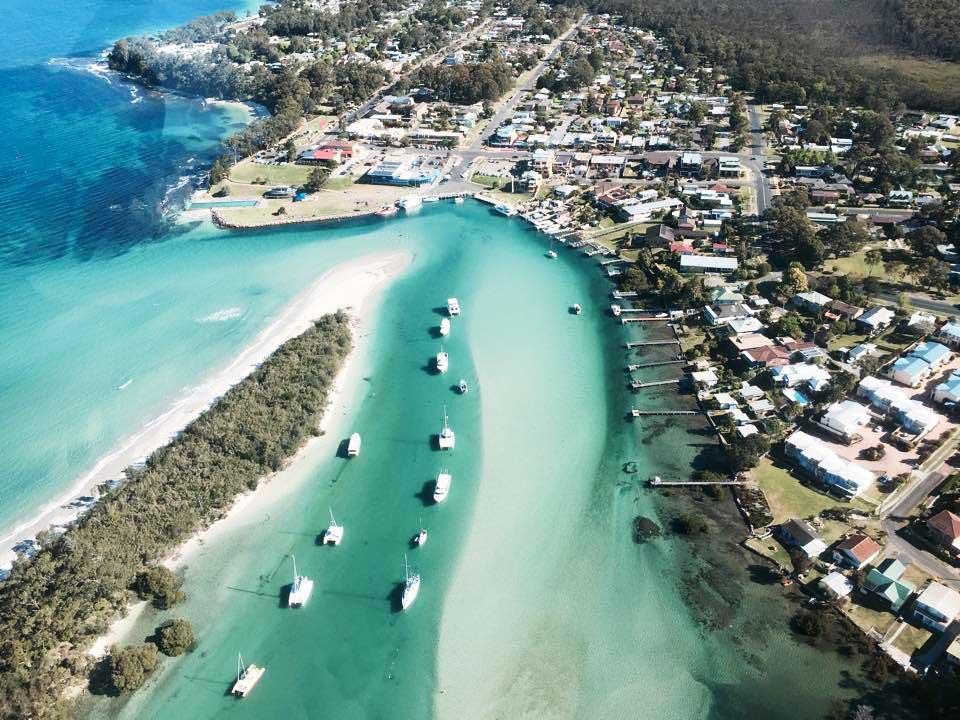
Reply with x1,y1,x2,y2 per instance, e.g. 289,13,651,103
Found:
0,312,352,719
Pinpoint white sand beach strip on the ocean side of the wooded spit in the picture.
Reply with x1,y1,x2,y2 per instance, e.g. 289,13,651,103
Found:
0,252,411,567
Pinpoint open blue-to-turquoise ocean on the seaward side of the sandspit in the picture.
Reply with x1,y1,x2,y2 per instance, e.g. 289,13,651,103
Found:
0,0,256,527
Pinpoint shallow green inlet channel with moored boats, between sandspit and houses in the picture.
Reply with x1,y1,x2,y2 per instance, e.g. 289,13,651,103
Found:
77,203,864,718
